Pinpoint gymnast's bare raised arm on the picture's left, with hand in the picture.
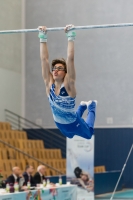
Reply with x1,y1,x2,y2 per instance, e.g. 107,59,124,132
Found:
40,27,53,95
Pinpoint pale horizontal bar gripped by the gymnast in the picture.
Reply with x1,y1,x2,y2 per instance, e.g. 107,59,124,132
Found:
0,23,133,34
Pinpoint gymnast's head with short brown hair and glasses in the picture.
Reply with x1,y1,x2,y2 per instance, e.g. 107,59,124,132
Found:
51,58,67,81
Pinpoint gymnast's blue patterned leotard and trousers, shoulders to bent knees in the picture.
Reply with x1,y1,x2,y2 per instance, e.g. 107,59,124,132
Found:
48,84,93,139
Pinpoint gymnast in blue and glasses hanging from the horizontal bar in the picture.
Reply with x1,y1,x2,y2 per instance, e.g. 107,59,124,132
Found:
38,25,97,139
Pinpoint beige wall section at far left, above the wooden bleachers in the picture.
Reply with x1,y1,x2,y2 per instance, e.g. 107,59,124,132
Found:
0,0,22,121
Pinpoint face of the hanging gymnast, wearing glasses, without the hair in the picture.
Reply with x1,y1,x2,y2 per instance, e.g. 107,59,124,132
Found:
52,63,66,81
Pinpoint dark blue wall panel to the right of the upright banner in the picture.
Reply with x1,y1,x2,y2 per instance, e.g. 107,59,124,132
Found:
94,128,133,188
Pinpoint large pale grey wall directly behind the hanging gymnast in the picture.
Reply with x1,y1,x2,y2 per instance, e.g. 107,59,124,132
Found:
26,0,133,127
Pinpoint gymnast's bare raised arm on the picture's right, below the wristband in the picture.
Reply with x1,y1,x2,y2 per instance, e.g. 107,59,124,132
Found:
64,35,76,97
